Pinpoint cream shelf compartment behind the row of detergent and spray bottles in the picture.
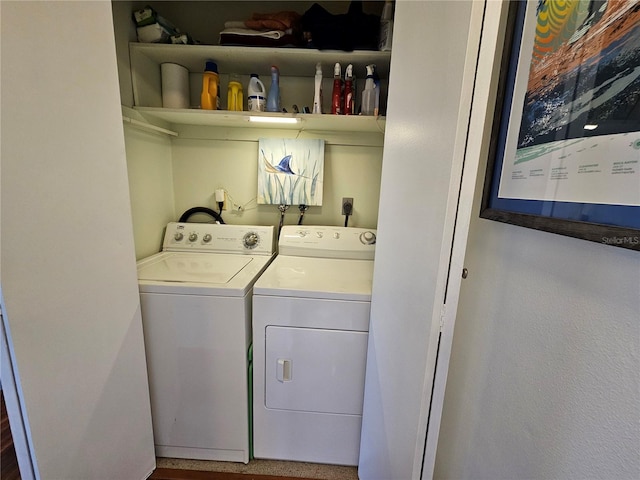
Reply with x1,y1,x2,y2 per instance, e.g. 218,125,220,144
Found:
129,43,391,134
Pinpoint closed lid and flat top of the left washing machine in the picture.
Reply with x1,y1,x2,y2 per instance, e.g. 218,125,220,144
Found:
138,253,252,284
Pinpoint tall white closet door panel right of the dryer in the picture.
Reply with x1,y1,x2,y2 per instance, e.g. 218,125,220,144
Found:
358,0,490,480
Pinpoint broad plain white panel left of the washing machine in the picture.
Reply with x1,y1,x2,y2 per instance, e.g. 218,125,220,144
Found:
0,2,155,479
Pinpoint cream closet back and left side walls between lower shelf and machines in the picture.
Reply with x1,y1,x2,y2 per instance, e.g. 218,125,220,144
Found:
125,125,382,259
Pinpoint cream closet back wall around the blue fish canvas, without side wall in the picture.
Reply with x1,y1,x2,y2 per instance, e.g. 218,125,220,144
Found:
172,127,382,228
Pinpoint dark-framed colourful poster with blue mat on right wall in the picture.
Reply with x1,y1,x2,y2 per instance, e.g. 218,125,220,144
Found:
480,0,640,250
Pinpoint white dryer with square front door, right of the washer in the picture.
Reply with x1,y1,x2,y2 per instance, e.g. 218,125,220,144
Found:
253,226,376,465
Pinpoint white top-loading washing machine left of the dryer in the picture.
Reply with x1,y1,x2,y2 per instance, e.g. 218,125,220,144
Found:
138,223,275,463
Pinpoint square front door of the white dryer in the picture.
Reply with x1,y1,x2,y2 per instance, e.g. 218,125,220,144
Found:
265,326,368,415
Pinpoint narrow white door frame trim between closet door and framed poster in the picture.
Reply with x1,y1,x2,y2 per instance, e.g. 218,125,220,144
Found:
414,1,508,480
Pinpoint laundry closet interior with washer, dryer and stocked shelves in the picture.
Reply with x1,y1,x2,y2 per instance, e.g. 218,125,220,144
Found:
113,2,391,466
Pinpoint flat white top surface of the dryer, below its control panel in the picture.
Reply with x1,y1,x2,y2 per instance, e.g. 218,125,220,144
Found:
253,255,373,301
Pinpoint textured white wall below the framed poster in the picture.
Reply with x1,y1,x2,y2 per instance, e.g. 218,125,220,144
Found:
434,1,640,480
